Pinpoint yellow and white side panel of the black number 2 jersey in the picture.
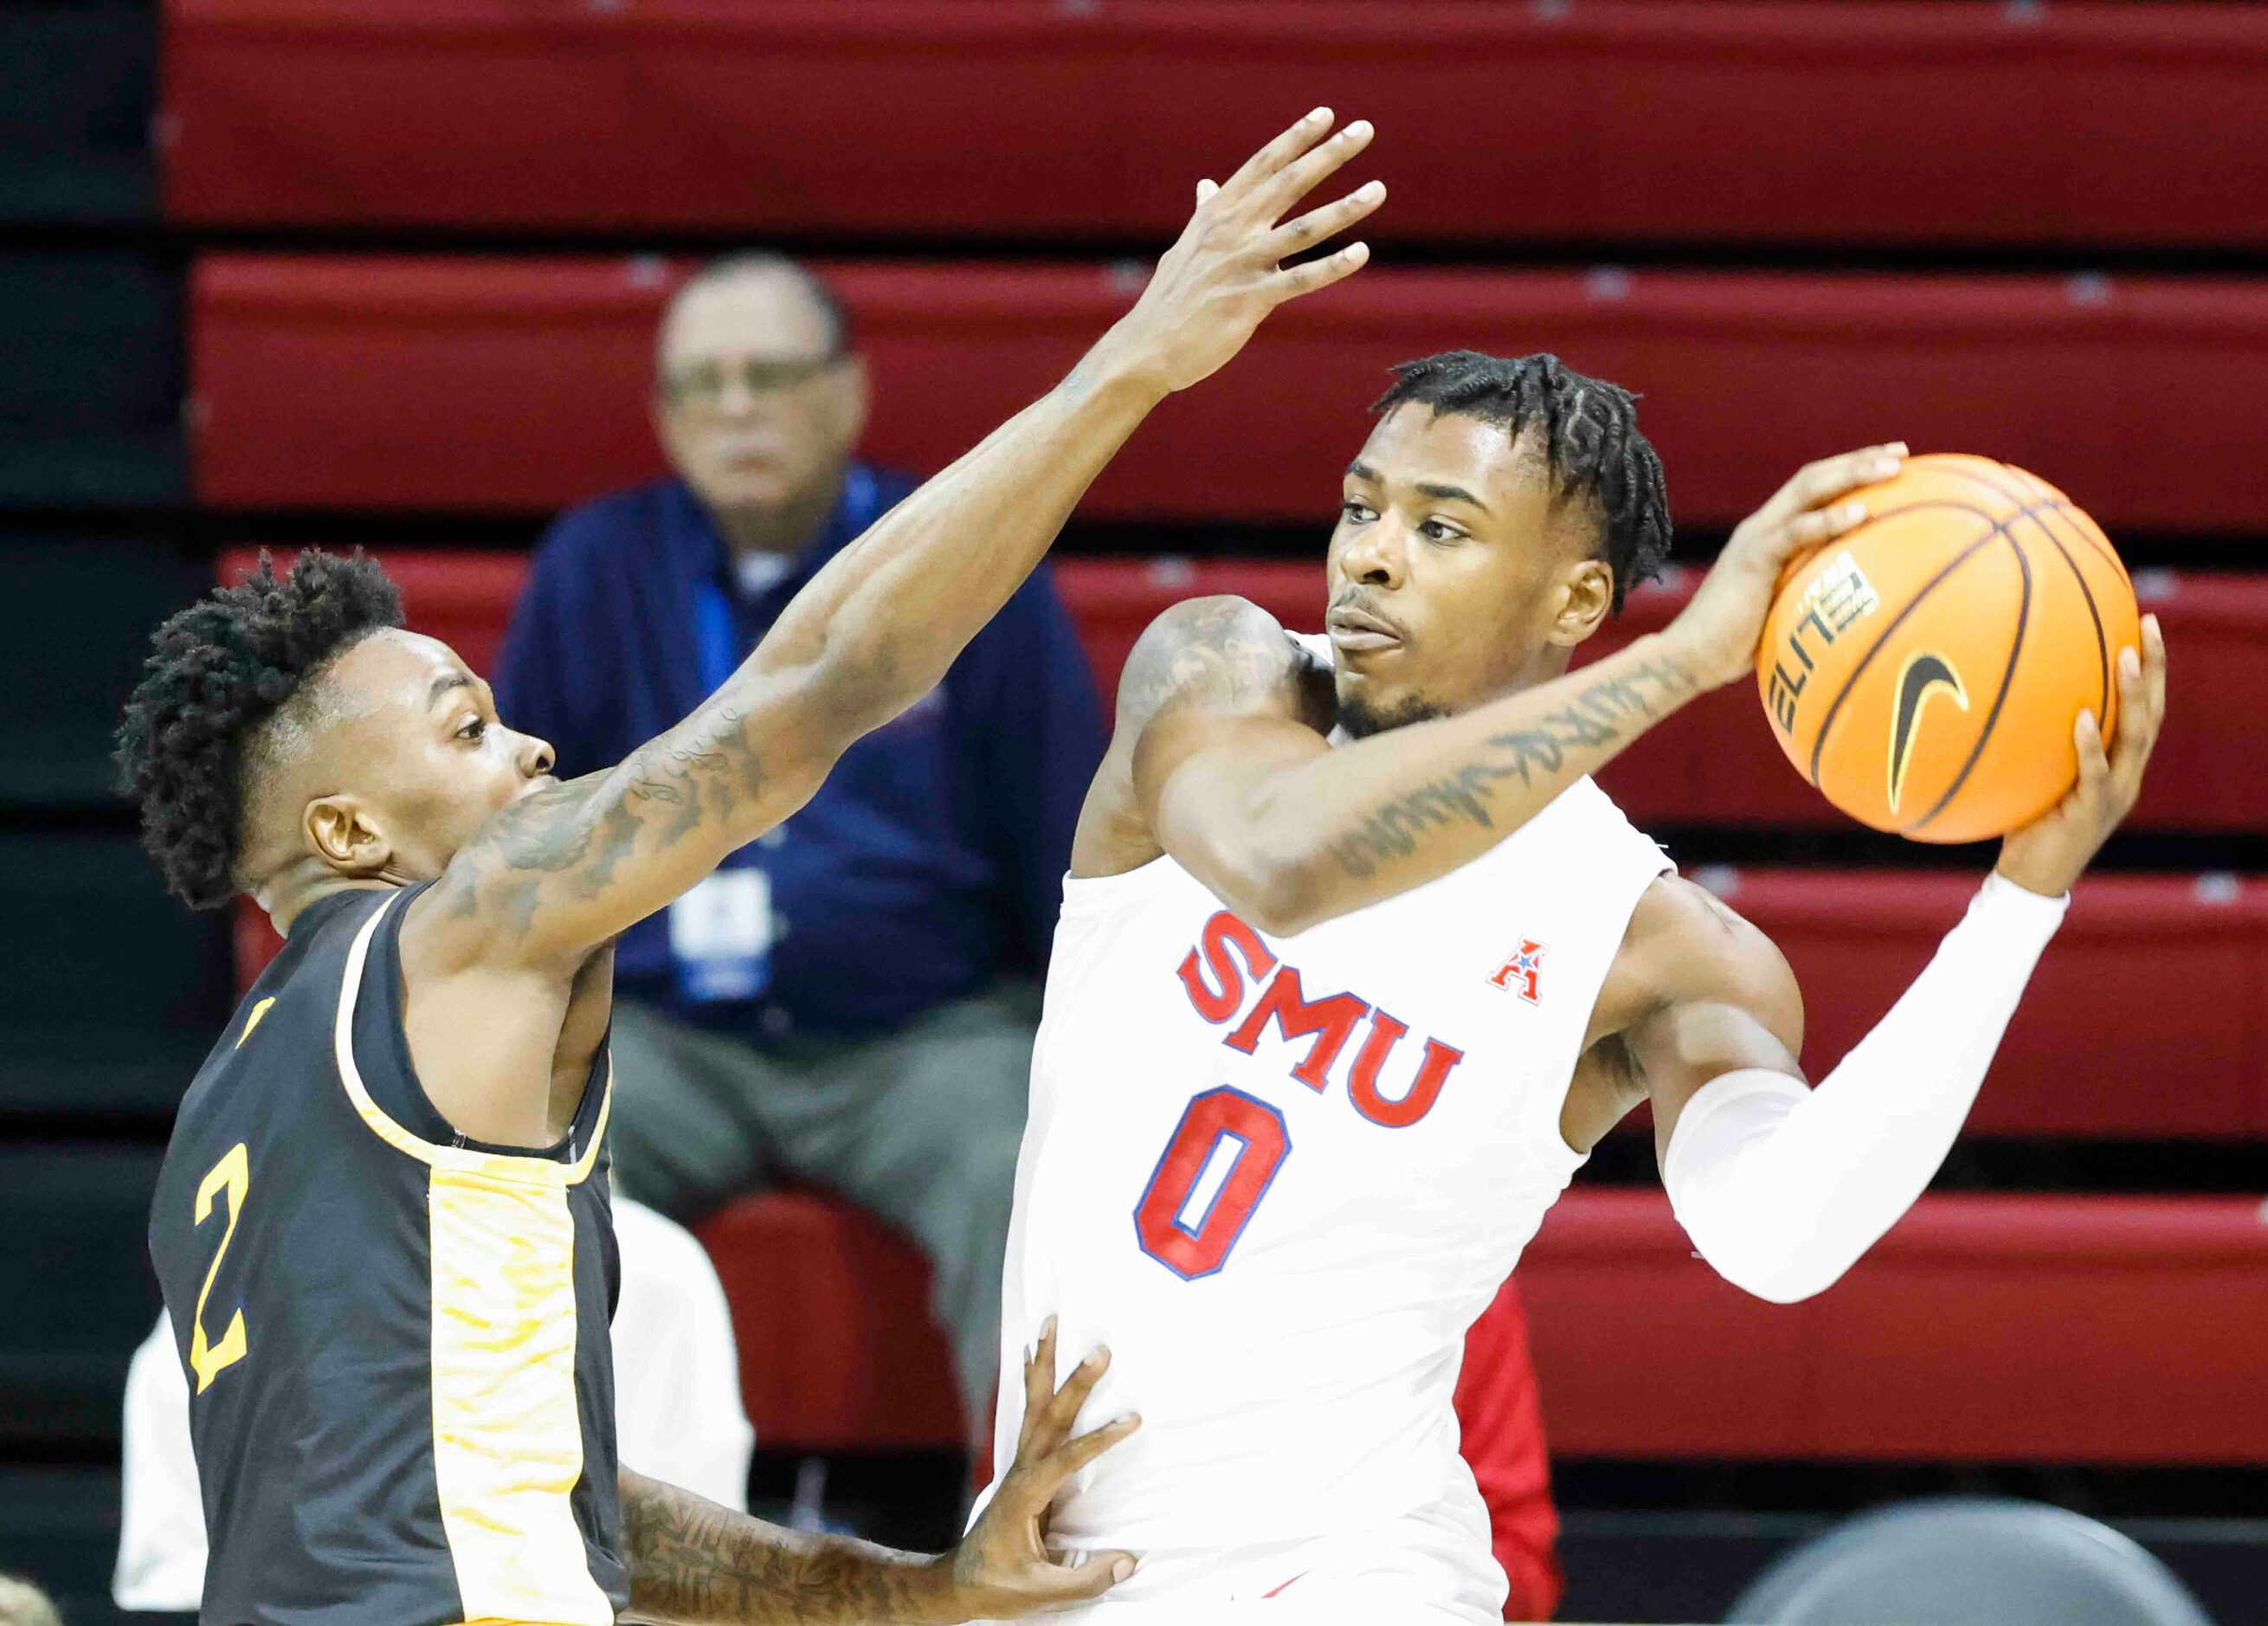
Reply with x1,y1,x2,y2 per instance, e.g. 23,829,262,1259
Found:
428,1168,615,1626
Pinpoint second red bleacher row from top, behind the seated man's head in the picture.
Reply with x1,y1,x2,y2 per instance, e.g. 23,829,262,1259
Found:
190,254,2268,532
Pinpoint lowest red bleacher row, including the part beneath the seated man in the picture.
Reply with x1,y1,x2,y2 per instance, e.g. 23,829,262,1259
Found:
680,1188,2268,1462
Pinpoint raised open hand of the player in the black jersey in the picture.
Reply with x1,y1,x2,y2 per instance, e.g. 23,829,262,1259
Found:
1105,106,1386,392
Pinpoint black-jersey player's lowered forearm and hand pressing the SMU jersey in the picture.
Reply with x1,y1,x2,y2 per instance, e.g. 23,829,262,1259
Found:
622,1320,1138,1626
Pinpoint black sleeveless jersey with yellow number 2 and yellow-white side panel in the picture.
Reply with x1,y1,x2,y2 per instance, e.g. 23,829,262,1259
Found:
150,889,628,1626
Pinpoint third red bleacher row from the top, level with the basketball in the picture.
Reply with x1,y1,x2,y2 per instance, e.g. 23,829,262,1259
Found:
220,549,2268,830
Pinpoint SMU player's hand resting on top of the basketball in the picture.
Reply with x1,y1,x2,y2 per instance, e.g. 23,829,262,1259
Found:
1669,440,1905,687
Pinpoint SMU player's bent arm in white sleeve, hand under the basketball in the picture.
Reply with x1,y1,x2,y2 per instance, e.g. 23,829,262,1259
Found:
1617,616,2166,1301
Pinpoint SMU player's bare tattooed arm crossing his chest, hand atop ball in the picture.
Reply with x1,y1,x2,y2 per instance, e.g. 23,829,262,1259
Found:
1113,447,1903,934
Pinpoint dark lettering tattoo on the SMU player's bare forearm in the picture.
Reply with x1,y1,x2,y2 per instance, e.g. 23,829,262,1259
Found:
1331,658,1698,880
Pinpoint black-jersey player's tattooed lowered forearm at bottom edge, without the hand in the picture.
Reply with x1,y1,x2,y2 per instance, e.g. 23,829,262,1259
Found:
622,1474,946,1626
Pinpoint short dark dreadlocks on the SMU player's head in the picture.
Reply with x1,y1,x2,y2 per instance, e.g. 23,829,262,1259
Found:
1369,349,1669,610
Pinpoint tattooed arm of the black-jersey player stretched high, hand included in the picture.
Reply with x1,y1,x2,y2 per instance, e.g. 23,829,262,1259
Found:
413,109,1386,964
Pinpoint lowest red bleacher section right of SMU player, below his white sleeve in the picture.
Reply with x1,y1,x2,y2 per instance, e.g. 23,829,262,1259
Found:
1517,1190,2268,1465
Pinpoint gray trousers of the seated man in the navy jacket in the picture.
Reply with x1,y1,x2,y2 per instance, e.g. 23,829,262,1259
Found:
612,984,1039,1444
